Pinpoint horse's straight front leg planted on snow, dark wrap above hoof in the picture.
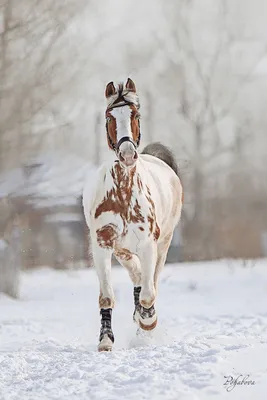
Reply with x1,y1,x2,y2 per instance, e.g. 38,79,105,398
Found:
93,245,115,351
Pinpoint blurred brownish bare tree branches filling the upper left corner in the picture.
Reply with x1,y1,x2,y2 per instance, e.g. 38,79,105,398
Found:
0,0,90,169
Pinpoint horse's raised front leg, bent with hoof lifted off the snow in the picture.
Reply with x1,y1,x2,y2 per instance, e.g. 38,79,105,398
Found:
134,242,157,330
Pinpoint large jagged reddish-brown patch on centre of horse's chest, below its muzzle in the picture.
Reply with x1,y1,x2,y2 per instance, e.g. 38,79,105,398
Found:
95,163,145,235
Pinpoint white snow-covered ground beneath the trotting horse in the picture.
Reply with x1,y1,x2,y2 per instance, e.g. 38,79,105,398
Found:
0,261,267,400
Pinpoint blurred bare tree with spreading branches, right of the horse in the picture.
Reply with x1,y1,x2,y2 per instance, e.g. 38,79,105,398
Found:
152,0,266,260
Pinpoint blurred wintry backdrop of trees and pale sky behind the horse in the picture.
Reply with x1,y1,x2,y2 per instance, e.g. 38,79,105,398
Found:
0,0,267,293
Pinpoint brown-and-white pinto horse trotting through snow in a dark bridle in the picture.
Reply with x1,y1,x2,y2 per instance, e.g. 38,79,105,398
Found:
83,78,183,351
